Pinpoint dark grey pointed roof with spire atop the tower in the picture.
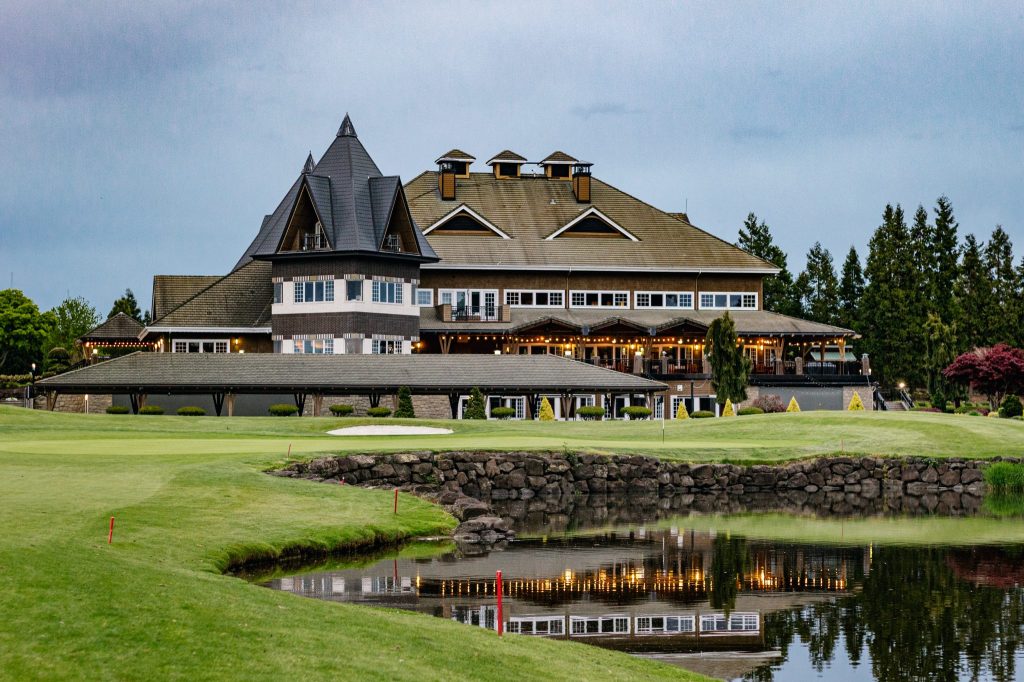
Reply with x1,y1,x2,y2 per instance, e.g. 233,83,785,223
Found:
234,115,434,269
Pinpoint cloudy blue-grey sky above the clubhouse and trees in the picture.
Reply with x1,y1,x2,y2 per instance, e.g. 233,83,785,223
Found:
0,0,1024,314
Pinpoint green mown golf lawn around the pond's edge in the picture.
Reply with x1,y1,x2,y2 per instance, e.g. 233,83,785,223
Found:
0,407,1024,680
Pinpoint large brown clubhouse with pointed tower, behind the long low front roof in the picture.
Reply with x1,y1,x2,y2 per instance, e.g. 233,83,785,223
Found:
56,116,870,418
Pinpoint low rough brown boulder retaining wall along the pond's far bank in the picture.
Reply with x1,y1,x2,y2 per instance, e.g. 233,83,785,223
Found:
274,452,1003,518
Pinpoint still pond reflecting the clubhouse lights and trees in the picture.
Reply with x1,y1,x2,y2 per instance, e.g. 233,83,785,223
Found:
248,499,1024,682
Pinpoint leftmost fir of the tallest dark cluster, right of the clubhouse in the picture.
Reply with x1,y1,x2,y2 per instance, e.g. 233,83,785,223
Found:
861,204,924,386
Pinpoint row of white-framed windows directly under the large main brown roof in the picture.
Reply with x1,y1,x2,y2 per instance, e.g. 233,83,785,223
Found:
415,289,758,310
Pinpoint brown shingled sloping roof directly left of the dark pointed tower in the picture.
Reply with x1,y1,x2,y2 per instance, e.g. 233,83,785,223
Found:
145,260,273,332
